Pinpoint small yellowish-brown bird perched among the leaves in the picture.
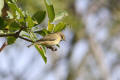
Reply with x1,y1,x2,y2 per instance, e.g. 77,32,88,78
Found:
28,32,65,47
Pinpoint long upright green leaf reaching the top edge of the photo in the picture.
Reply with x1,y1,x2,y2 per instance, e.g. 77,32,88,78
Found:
44,0,55,22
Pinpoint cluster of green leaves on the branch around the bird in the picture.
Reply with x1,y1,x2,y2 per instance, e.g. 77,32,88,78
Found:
0,0,67,63
